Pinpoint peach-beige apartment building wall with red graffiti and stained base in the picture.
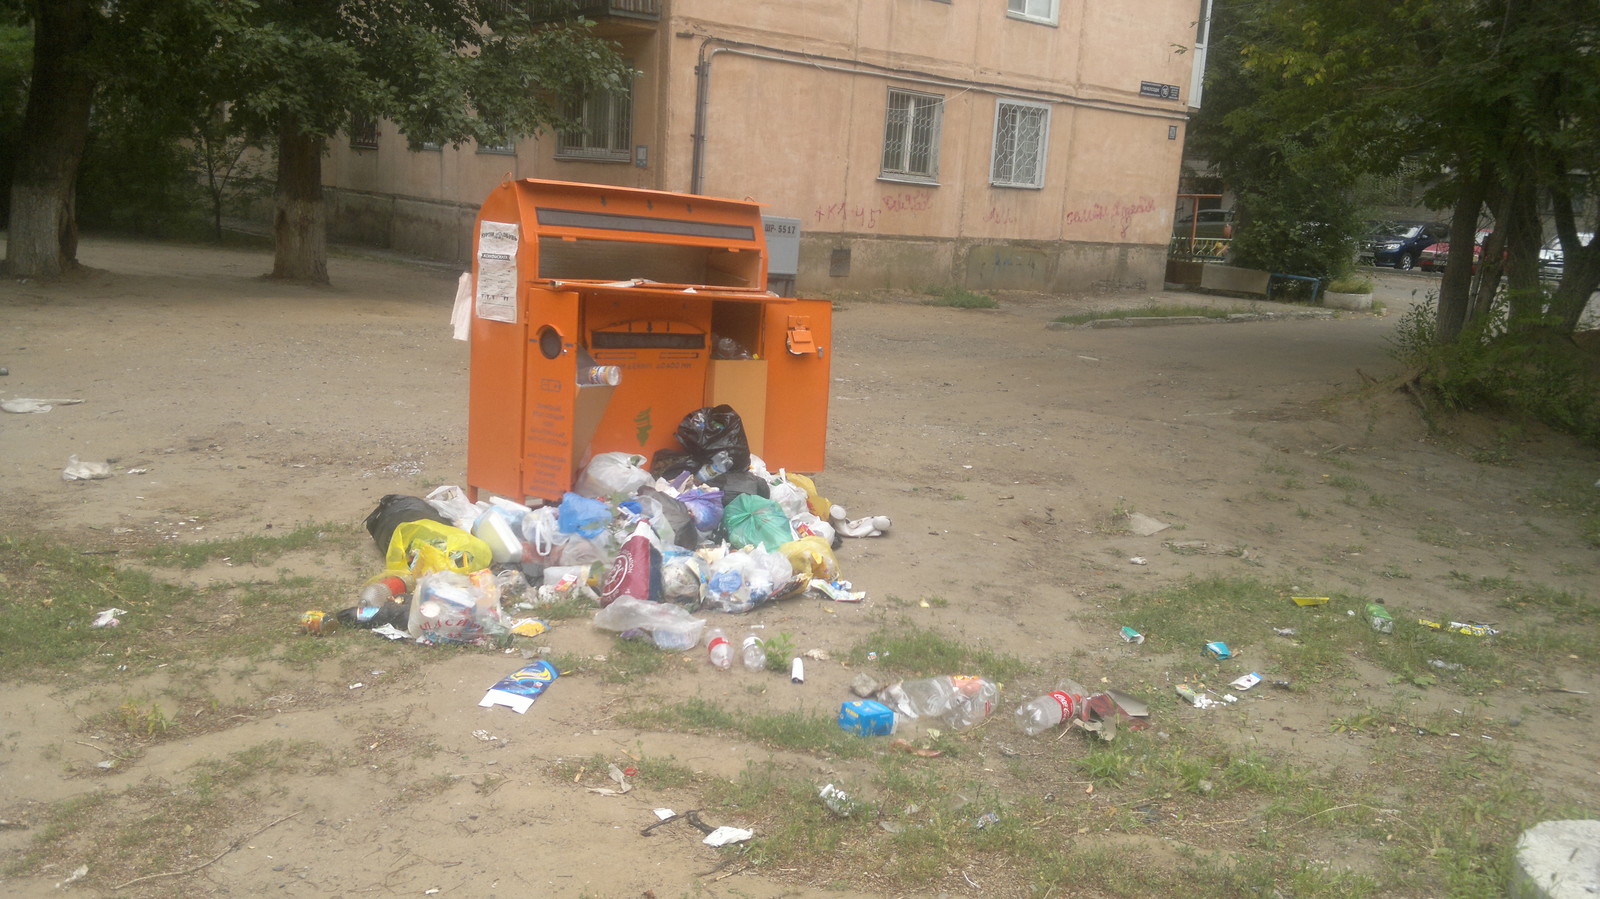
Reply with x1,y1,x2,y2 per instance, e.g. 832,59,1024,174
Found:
326,0,1200,293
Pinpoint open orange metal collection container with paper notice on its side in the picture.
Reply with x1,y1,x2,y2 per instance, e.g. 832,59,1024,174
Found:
467,179,832,502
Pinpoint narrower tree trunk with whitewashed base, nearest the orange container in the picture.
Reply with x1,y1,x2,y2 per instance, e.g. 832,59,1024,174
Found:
272,117,328,285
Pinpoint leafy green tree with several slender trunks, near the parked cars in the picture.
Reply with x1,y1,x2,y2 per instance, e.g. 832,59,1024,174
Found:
1219,0,1600,344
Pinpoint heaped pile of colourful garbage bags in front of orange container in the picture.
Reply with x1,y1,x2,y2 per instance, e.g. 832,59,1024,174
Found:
306,406,891,651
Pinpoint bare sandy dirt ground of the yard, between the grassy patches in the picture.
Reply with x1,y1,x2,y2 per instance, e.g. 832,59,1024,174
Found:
0,238,1600,897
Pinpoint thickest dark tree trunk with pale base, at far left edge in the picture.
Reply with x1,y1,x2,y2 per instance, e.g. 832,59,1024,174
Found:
6,0,96,278
